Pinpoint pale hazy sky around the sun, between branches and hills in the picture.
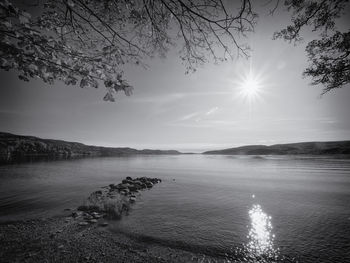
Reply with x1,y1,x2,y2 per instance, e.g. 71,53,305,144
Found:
0,1,350,152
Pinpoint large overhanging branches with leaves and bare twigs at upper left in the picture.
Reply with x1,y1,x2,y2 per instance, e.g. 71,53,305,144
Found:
0,0,257,101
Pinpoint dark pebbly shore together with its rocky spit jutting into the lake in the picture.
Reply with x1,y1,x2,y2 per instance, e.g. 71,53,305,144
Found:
0,177,224,263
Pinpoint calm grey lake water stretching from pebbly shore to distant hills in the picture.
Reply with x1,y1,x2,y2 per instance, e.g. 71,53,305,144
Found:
0,155,350,262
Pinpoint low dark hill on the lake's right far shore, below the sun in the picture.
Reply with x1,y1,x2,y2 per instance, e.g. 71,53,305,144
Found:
203,141,350,155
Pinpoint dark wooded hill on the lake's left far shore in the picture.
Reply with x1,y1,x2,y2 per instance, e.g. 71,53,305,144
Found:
0,132,181,162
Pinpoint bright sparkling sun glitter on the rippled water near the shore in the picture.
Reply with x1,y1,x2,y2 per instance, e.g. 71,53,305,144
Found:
246,204,278,258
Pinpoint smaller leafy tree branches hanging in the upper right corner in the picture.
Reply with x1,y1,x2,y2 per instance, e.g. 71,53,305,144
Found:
274,0,350,94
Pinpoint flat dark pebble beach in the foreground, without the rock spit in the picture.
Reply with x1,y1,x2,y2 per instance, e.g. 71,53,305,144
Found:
0,215,224,263
